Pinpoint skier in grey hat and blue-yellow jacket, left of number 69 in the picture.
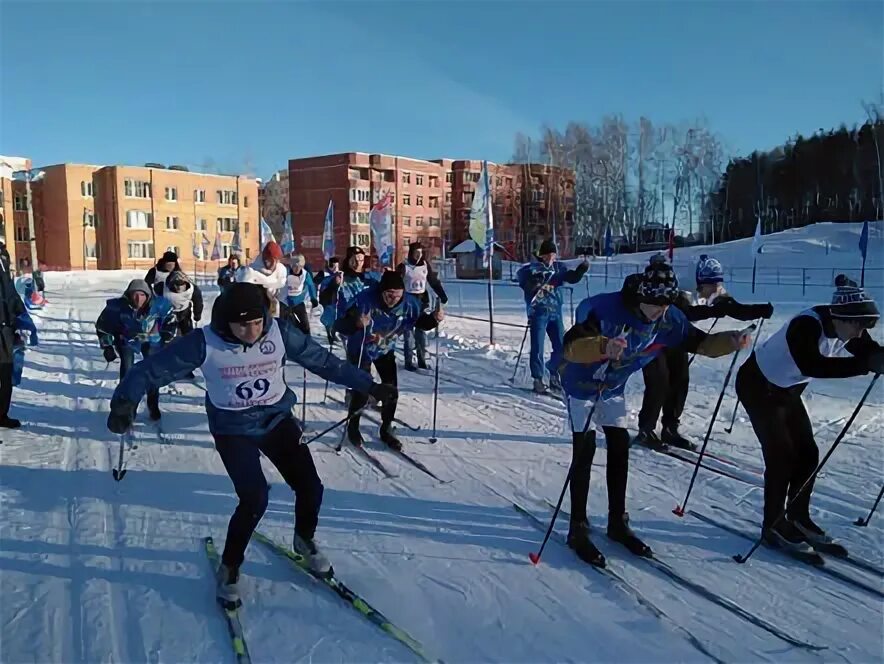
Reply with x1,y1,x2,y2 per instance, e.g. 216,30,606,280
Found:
95,279,178,421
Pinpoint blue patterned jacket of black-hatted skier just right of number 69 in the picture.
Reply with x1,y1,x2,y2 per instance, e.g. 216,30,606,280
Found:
335,285,438,361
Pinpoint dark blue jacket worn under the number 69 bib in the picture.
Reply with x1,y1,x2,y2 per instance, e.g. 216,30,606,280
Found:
111,295,373,436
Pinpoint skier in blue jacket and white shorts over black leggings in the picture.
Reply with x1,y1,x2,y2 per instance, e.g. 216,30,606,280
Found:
560,264,750,565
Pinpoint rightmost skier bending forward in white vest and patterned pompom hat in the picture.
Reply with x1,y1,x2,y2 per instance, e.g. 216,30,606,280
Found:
736,275,884,555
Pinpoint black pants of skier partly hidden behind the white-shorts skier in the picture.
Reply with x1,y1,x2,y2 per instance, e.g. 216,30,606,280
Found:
638,347,691,431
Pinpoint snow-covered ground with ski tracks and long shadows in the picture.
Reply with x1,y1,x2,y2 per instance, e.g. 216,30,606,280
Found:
0,225,884,663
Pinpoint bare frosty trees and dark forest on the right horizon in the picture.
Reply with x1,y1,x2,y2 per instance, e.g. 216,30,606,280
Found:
512,104,884,252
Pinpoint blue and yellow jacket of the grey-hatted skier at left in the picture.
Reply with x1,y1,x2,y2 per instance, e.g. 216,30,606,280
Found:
95,295,178,353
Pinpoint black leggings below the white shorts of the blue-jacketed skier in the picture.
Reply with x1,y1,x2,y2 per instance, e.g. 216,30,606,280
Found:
570,423,629,522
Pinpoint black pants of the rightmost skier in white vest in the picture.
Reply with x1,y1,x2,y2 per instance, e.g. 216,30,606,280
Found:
736,353,820,528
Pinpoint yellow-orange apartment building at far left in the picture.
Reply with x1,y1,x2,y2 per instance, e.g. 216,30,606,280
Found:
0,164,258,273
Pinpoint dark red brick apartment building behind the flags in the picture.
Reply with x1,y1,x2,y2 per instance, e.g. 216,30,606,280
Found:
288,152,574,267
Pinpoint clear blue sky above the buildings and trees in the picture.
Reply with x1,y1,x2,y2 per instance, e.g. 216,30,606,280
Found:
0,0,884,177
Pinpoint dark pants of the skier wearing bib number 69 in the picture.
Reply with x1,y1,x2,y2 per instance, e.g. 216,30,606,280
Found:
214,417,323,568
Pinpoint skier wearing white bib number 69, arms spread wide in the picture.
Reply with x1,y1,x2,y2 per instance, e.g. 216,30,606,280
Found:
107,283,396,606
